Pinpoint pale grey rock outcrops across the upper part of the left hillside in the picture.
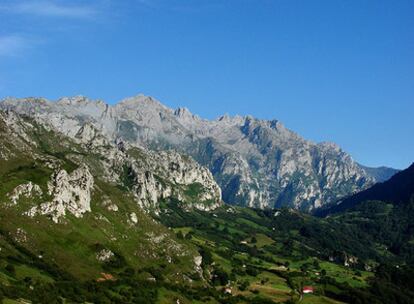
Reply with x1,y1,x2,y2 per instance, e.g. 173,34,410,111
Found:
0,109,222,224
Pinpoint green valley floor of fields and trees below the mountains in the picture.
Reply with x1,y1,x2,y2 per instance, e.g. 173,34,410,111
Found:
156,203,382,303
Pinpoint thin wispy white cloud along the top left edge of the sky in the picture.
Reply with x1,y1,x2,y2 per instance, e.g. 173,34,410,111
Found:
0,0,97,18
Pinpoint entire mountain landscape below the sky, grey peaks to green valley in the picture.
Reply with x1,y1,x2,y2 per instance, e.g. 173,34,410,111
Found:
0,96,414,304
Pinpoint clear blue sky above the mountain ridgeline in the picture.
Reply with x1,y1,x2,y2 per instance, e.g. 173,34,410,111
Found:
0,0,414,168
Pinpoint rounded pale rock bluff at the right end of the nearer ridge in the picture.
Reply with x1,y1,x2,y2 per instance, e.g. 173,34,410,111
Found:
124,150,221,211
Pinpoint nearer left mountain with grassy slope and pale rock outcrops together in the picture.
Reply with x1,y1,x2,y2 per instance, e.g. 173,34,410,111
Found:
0,111,222,279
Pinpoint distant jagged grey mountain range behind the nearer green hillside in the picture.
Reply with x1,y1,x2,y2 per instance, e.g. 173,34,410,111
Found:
0,95,386,211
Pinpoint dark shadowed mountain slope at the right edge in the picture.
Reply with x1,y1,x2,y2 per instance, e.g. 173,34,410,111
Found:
316,163,414,265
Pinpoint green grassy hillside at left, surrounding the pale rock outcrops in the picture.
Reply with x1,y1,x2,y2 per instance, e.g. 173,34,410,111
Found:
0,116,204,302
